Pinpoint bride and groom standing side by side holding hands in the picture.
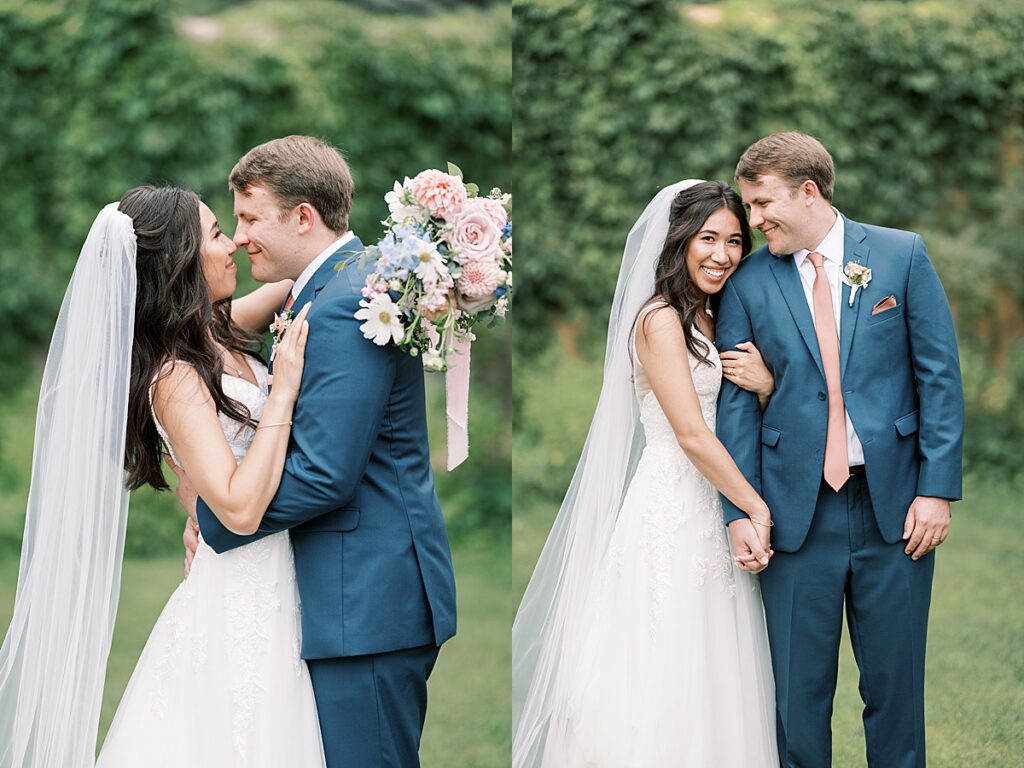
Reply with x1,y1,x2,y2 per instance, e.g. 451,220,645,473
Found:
513,132,964,768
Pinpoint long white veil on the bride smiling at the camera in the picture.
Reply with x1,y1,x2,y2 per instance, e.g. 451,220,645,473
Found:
512,179,700,768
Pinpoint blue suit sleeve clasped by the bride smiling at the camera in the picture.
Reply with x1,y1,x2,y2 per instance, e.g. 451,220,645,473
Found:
715,281,761,524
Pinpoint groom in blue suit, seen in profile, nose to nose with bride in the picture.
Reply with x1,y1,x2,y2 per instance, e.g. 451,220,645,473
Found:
185,136,456,768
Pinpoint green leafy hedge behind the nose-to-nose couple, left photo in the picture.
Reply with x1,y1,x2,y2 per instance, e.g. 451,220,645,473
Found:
0,0,512,555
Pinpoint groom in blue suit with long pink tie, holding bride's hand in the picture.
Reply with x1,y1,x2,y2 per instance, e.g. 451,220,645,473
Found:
717,132,964,768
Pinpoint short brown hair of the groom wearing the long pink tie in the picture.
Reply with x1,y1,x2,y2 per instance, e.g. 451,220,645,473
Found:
736,131,836,203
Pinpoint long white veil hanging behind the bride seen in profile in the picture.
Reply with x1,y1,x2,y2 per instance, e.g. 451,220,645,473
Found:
0,203,136,768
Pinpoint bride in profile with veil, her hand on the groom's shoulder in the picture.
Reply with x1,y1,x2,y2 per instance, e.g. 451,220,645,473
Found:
0,186,324,768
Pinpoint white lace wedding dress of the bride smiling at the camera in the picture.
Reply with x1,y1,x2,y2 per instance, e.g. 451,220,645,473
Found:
543,331,778,768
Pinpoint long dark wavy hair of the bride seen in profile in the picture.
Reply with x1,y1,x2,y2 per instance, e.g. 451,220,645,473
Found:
118,185,259,490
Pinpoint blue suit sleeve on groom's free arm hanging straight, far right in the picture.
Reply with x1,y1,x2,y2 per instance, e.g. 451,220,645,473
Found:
906,236,964,500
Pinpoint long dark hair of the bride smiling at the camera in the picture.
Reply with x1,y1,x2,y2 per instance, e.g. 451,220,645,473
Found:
644,181,751,365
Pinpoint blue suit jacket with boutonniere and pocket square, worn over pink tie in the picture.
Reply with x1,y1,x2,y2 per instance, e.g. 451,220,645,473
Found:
716,217,964,552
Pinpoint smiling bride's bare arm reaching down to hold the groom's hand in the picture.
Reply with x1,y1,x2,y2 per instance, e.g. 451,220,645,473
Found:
636,307,772,572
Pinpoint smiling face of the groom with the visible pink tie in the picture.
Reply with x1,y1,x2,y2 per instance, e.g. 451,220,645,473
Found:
739,173,815,256
